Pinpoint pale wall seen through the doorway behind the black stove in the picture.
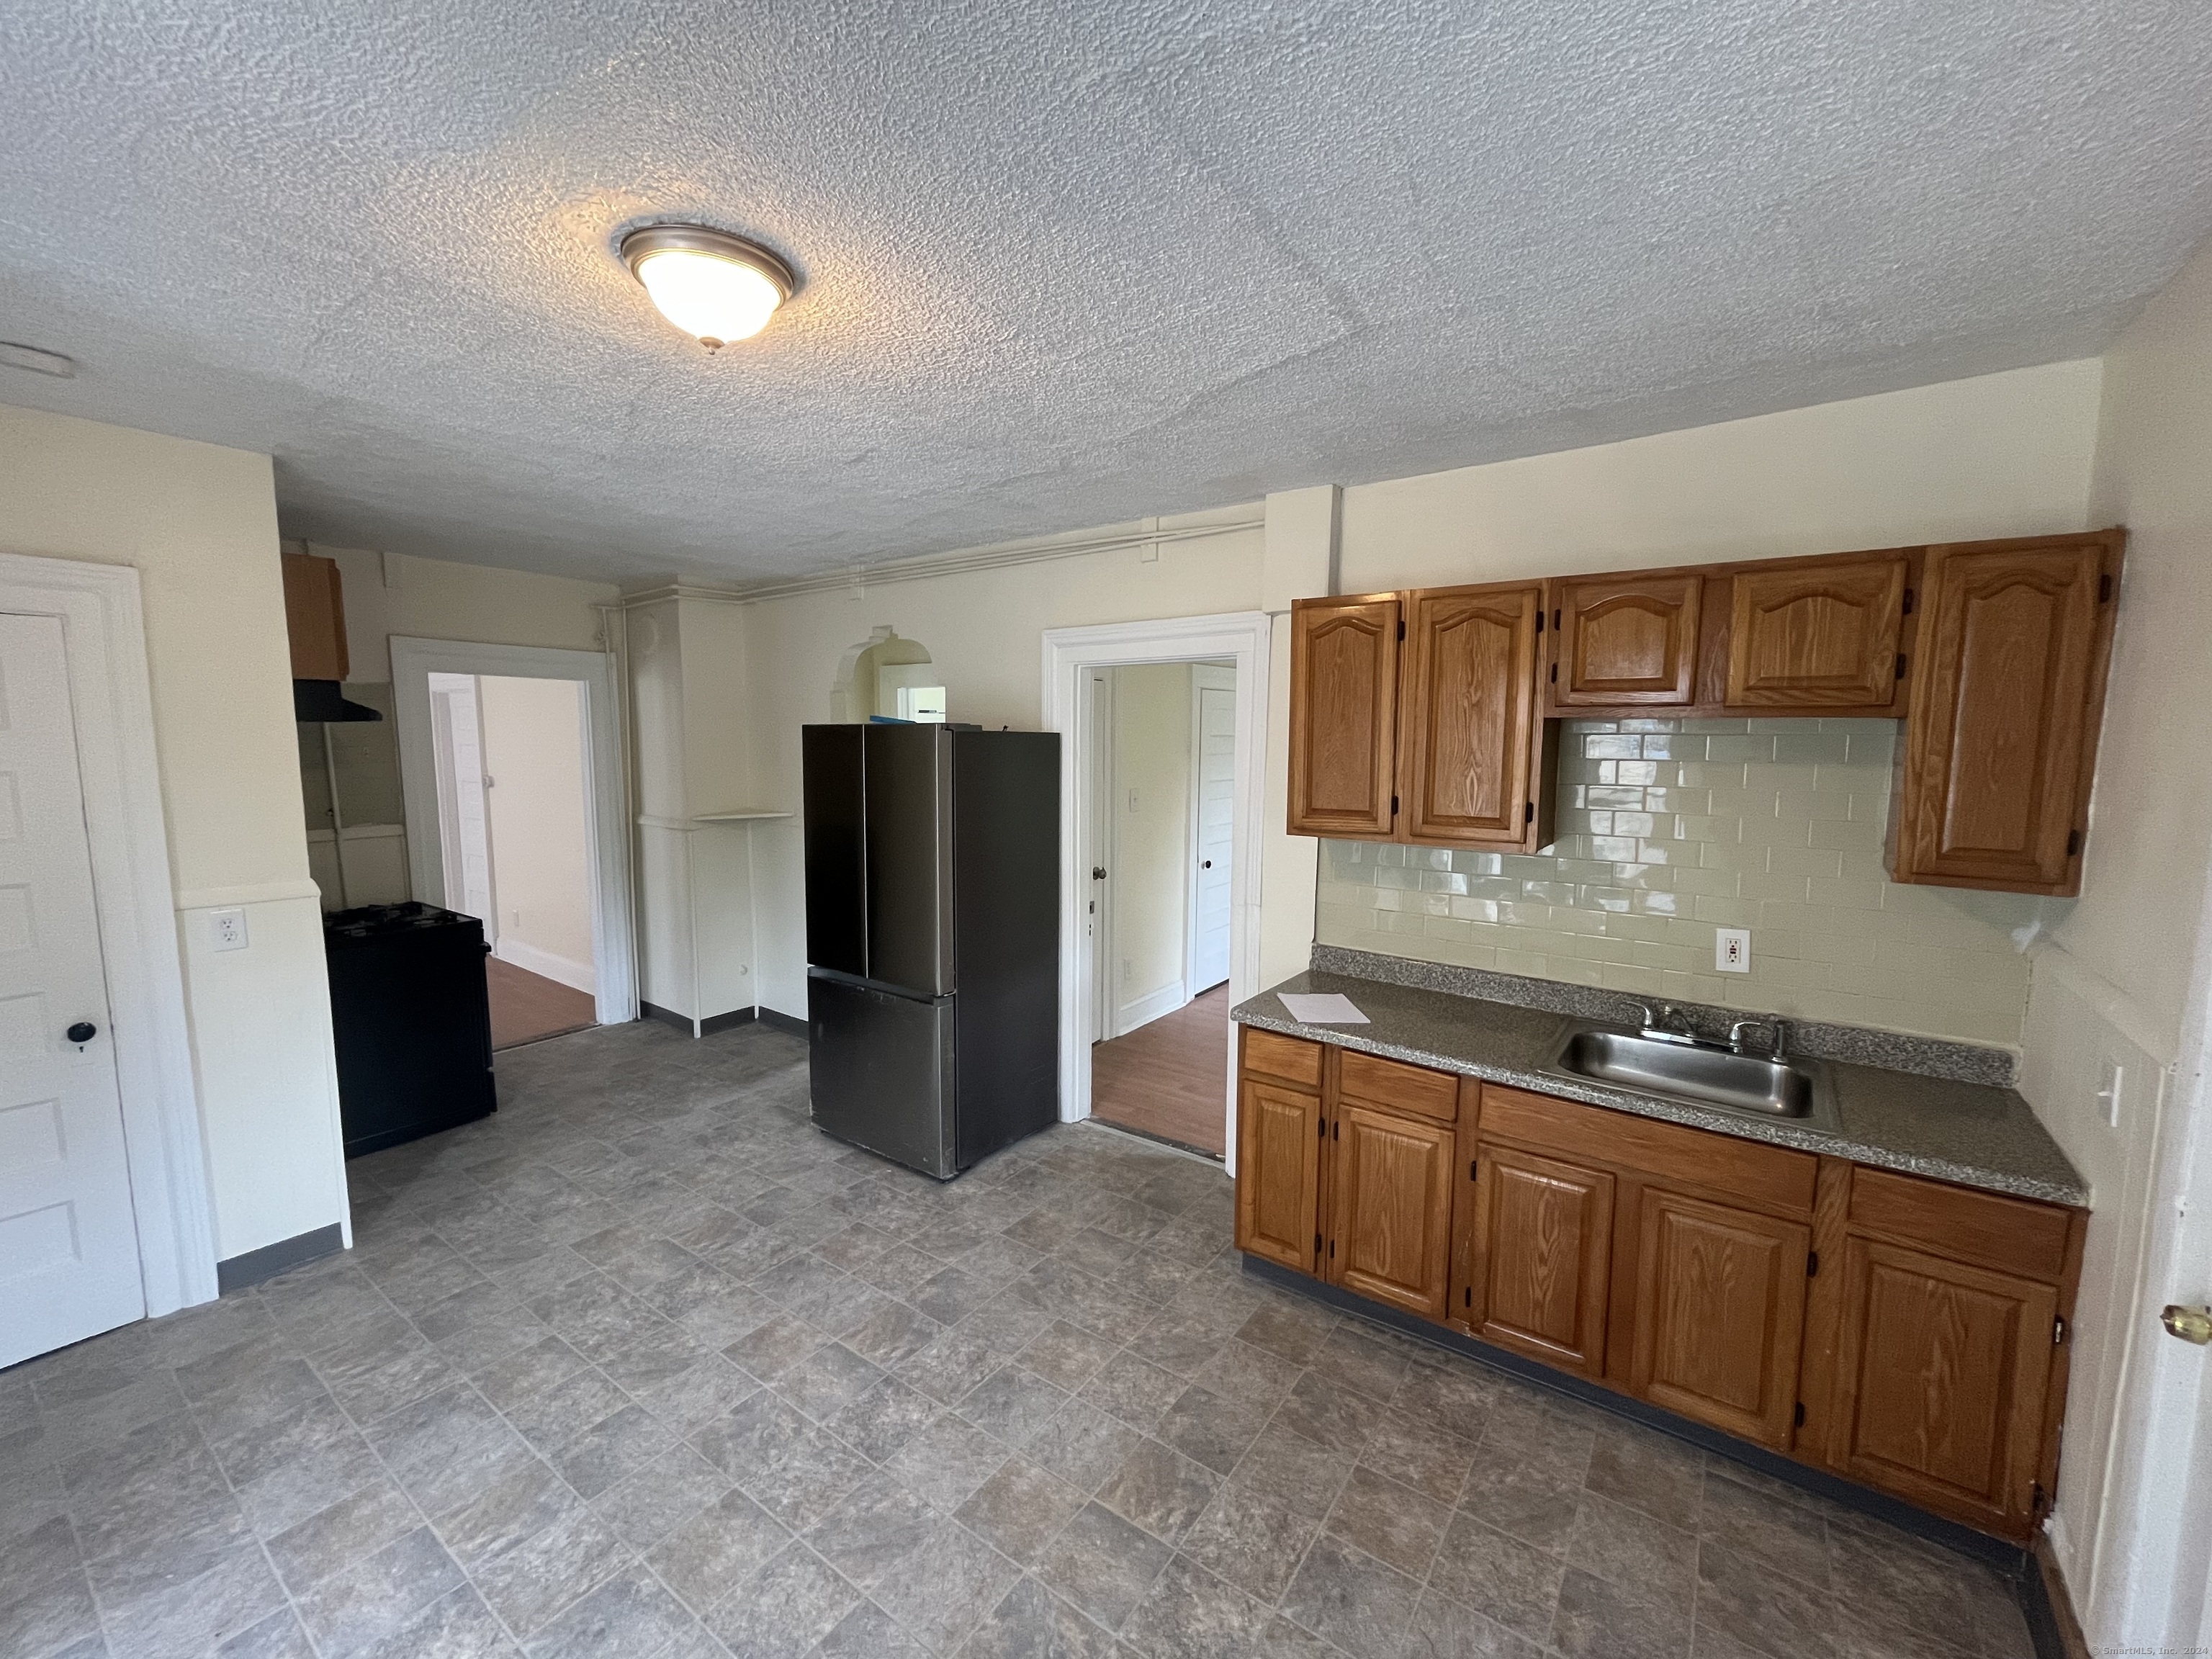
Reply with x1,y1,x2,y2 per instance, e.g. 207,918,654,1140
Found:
475,675,595,991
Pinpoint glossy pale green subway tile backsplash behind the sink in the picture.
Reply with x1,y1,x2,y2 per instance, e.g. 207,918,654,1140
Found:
1316,719,2072,1046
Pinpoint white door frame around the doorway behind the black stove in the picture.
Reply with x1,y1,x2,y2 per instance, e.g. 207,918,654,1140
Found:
392,635,637,1024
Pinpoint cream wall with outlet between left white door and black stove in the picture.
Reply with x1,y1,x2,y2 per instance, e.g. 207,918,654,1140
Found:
0,407,345,1256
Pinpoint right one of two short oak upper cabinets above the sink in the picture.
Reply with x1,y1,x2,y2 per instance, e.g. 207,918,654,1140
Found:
1725,553,1909,712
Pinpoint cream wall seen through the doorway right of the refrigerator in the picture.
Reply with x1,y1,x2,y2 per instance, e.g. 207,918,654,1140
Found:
1108,664,1190,1031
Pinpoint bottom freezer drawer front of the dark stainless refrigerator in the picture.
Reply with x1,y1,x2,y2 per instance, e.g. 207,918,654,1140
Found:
807,974,960,1181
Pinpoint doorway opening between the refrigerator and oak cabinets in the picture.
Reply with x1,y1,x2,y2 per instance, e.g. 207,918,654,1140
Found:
1084,659,1236,1159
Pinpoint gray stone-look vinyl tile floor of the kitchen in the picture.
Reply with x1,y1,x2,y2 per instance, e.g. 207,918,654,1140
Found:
0,1024,2031,1659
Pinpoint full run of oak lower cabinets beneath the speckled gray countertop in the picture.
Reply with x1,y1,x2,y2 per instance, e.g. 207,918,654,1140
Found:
1236,1033,2086,1539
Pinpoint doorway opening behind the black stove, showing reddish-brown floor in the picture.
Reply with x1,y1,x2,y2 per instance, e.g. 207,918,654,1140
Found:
429,673,600,1048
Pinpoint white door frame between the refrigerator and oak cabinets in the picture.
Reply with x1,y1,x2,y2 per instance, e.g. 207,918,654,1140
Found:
1044,611,1274,1174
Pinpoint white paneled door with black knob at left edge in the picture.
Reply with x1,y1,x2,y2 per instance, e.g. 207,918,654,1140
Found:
0,613,146,1364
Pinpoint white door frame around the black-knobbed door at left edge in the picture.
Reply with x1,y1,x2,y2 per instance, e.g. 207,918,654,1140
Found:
0,553,217,1318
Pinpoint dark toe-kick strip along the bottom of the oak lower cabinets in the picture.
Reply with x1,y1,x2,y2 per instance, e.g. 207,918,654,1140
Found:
1243,1256,2026,1575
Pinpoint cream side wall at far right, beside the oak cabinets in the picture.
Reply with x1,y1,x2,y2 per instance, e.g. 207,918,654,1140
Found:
2020,240,2212,1650
